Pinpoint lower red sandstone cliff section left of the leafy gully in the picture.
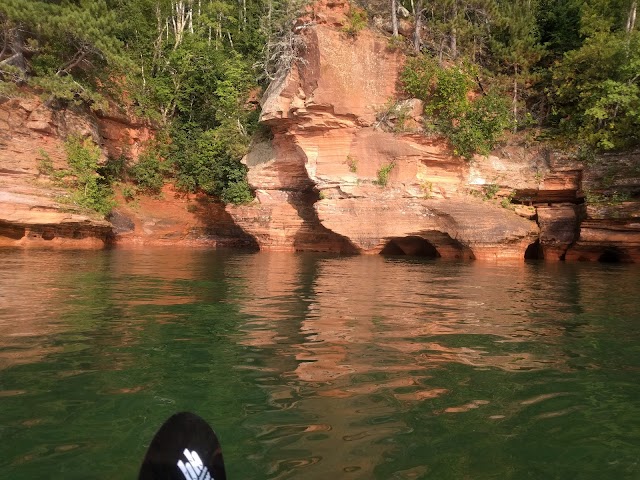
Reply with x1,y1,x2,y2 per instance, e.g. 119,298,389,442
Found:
0,92,254,248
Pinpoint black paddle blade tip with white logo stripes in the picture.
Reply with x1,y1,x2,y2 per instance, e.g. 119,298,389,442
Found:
138,412,227,480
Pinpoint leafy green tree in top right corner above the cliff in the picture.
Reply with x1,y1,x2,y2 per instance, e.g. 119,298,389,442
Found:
550,0,640,151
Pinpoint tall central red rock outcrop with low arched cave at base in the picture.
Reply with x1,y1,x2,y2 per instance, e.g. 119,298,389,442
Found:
228,16,538,259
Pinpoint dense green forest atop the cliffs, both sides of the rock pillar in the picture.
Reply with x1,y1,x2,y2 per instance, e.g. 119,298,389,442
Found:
0,0,640,206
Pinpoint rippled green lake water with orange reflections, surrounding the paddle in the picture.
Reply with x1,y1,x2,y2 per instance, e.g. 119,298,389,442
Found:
0,249,640,480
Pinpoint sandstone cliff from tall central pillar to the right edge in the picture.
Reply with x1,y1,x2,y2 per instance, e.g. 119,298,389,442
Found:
227,2,640,261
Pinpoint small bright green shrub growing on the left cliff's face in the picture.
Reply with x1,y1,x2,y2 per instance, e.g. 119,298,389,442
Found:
65,135,115,216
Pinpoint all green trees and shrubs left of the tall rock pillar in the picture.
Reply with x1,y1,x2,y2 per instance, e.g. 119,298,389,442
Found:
0,0,260,203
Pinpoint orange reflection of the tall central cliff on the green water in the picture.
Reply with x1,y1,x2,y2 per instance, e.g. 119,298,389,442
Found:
235,254,633,478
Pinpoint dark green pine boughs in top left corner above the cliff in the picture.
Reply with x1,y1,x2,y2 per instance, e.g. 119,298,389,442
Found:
0,0,127,108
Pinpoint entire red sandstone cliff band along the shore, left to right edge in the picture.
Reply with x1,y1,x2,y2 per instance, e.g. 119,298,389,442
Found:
0,1,640,262
